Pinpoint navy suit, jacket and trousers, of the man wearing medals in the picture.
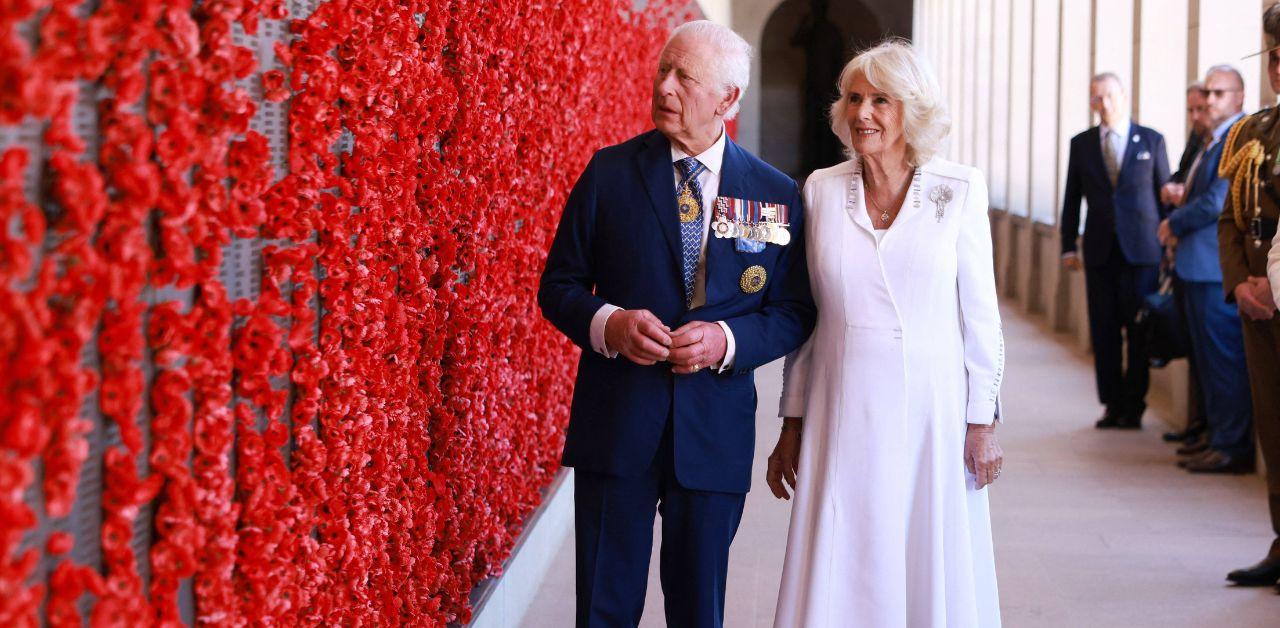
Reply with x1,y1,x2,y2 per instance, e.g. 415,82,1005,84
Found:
538,130,815,625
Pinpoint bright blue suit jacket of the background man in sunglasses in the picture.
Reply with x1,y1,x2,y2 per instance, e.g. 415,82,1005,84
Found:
1169,120,1230,281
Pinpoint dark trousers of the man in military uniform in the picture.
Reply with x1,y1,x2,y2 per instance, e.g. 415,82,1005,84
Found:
1243,318,1280,542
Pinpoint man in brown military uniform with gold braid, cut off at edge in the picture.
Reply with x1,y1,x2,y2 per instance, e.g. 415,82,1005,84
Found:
1217,5,1280,586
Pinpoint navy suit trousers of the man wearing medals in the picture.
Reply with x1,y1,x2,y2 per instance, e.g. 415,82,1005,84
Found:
573,422,746,628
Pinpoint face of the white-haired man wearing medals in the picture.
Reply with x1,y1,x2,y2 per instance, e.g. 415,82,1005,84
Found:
652,36,735,145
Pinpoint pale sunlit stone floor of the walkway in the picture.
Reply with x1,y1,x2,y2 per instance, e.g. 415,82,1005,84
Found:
524,306,1280,628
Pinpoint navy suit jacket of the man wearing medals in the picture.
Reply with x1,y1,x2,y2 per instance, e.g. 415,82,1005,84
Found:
538,130,815,492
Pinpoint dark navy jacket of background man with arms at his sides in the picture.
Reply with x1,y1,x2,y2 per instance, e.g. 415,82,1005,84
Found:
1061,123,1169,266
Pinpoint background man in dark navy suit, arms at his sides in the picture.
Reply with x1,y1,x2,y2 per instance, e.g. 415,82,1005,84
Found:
1061,73,1169,428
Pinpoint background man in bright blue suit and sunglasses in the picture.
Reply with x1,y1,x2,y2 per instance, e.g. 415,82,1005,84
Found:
1158,65,1254,473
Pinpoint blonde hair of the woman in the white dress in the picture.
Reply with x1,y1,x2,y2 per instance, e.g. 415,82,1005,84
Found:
831,38,951,166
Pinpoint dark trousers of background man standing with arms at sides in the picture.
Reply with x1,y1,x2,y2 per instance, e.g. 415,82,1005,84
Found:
1084,246,1160,420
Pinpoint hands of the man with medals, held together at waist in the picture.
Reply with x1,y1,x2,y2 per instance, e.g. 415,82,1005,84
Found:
604,310,728,375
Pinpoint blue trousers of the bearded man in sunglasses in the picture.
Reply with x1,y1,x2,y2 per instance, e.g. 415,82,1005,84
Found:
1183,281,1253,458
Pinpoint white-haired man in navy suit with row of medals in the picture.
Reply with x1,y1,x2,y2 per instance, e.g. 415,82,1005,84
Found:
538,22,815,627
